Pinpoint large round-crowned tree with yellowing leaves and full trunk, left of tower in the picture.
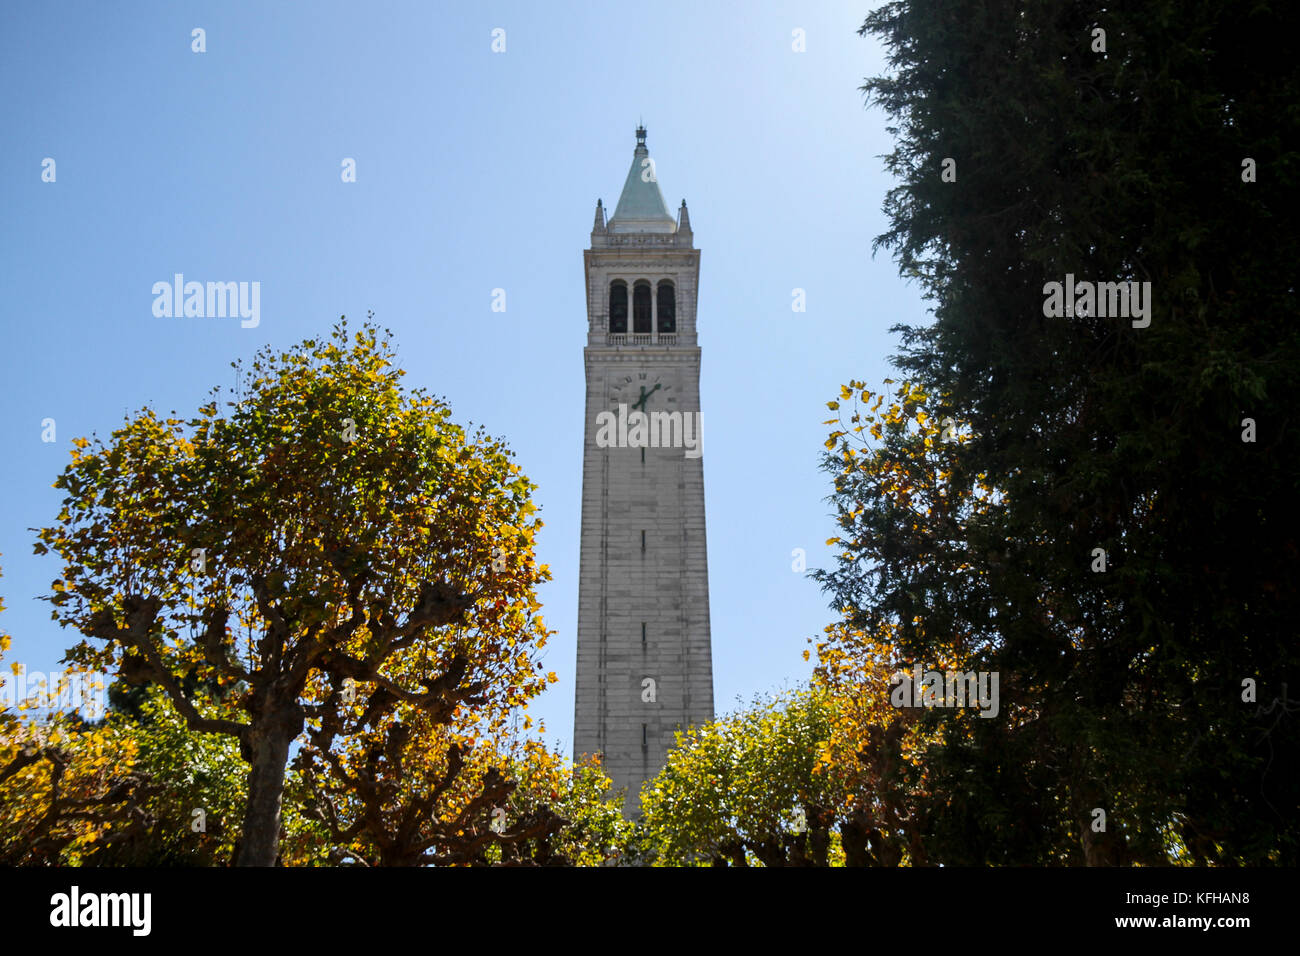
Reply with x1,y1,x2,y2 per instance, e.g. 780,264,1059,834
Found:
36,320,549,866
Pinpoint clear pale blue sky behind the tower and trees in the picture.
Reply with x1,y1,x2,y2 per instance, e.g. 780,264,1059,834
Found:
0,0,926,752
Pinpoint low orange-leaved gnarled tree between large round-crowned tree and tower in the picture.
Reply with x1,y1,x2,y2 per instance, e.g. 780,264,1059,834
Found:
288,711,628,866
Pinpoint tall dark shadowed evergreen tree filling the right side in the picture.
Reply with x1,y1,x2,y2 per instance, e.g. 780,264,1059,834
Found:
823,0,1300,864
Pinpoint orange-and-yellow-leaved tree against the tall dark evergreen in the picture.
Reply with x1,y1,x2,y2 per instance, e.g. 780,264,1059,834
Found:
813,378,1078,865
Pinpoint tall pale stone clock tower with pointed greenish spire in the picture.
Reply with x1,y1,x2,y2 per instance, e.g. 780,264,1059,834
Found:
573,127,714,814
